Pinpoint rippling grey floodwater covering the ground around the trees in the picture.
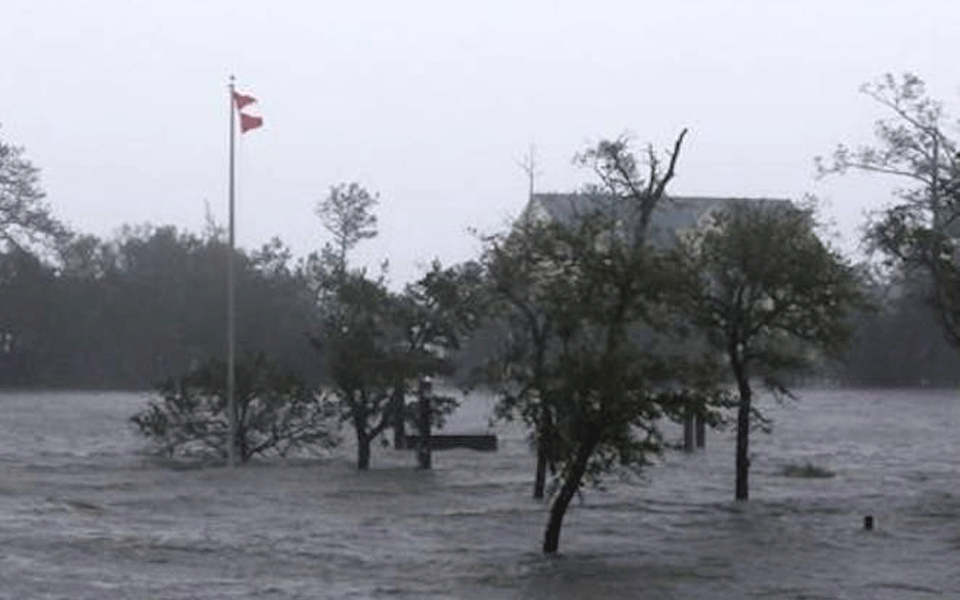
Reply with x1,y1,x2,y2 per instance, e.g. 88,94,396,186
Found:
0,390,960,600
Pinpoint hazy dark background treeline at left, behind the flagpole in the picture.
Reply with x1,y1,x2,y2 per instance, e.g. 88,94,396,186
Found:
0,226,318,389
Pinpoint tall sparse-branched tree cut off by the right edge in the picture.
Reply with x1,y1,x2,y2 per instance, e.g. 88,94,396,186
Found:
817,73,960,348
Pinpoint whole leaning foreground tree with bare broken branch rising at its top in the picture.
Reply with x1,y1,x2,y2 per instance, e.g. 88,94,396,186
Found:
488,131,728,553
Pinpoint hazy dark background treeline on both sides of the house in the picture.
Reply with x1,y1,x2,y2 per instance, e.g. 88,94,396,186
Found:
0,220,960,389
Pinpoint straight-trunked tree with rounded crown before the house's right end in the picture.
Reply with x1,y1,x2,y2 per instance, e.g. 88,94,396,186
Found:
673,200,865,500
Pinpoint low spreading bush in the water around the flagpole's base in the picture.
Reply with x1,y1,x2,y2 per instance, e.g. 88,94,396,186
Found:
131,355,338,462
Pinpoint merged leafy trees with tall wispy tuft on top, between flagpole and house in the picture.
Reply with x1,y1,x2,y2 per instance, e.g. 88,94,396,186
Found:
309,184,480,469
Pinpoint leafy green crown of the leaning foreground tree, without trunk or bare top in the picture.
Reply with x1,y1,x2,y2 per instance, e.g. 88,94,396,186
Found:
486,217,721,483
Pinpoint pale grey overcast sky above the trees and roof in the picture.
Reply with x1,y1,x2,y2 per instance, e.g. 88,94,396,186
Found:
0,0,960,283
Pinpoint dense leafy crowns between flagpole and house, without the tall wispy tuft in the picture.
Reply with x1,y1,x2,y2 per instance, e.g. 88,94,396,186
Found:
311,264,478,462
